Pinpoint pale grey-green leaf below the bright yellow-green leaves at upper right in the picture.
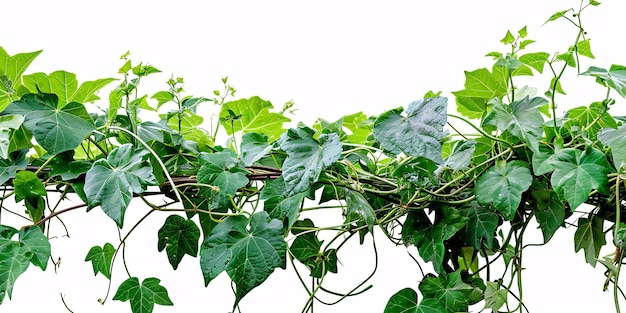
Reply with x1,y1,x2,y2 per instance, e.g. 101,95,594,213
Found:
483,97,548,151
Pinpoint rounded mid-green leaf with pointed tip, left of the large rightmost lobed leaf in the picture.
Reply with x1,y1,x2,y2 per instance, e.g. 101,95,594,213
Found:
474,161,533,220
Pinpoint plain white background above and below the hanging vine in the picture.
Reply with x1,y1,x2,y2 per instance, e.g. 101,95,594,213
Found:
0,0,626,313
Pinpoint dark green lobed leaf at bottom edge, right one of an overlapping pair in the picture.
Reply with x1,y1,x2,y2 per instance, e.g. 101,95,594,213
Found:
419,271,474,312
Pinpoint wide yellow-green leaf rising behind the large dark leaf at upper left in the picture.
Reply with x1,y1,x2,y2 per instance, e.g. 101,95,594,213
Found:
23,71,115,108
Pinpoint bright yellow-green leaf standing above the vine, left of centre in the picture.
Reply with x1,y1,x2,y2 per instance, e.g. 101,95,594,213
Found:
220,96,291,141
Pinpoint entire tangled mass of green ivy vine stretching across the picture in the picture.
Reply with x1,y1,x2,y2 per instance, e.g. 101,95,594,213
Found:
0,0,626,313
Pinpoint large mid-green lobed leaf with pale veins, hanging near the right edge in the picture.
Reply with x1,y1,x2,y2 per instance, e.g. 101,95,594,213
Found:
550,148,611,211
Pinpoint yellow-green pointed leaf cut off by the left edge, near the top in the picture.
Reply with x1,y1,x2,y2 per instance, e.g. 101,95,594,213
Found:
0,47,41,112
